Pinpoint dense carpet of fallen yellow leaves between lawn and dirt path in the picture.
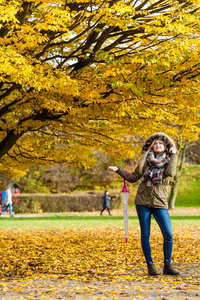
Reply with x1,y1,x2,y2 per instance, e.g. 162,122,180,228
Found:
0,226,200,284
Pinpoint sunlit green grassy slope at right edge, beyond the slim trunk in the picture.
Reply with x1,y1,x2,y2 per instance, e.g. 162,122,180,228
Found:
175,164,200,207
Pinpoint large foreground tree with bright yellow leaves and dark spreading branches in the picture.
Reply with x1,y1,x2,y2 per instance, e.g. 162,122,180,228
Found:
0,0,200,175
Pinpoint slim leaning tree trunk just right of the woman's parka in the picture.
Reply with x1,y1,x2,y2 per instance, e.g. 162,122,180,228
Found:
168,142,187,209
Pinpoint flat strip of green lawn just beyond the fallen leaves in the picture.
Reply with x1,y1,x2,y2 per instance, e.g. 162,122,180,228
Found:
0,215,200,229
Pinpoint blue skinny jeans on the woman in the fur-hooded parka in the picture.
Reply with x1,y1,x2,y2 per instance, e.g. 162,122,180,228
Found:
136,205,173,265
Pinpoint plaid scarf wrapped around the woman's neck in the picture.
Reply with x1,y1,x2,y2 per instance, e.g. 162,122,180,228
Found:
144,151,168,185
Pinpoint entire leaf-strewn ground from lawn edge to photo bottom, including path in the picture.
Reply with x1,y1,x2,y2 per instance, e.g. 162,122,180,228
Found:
0,226,200,300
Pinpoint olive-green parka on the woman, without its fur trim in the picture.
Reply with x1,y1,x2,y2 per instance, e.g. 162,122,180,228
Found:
116,154,177,208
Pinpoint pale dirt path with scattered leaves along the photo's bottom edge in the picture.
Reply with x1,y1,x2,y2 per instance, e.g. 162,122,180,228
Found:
0,264,200,300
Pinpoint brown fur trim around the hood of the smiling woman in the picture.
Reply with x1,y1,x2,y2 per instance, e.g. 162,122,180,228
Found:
142,132,176,154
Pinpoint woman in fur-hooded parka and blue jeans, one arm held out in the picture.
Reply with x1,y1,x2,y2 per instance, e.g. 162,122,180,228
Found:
108,132,179,276
